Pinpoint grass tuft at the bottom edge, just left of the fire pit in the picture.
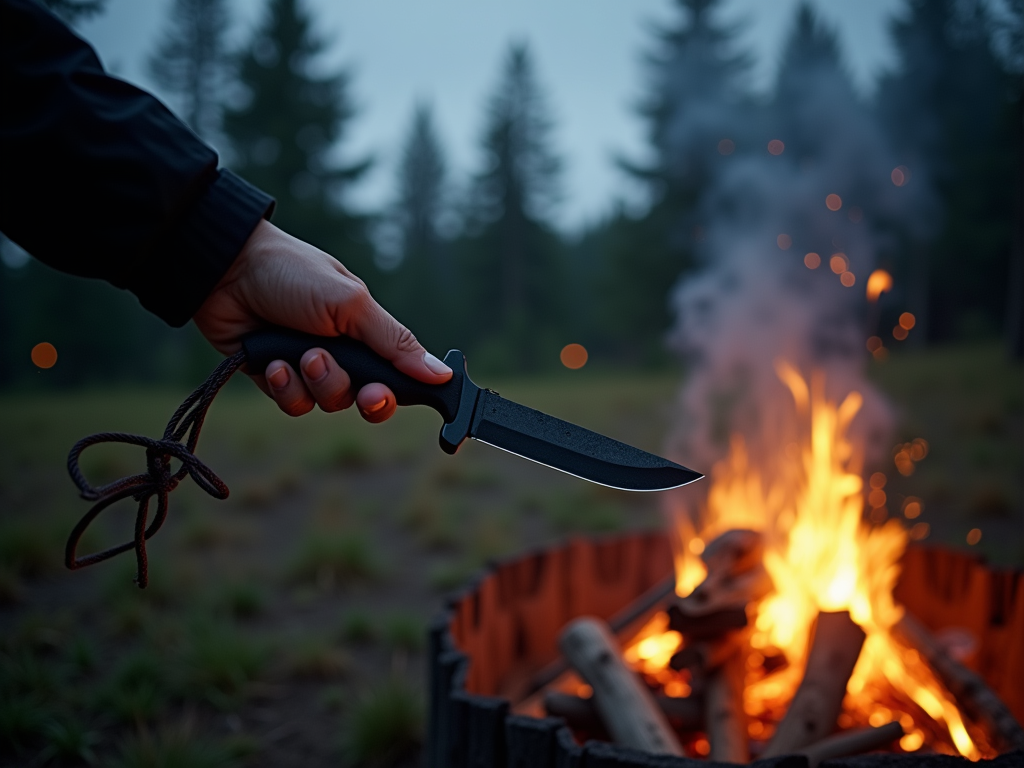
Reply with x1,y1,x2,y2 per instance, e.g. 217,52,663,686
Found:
345,680,423,766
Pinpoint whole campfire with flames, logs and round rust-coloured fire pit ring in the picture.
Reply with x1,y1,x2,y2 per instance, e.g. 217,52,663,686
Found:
430,360,1024,768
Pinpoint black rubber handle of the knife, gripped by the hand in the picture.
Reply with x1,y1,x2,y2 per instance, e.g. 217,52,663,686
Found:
242,329,465,423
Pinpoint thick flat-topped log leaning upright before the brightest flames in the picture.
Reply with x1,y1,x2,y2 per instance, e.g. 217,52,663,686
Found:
762,611,864,758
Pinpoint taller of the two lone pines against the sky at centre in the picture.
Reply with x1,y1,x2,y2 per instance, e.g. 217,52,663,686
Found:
467,43,564,366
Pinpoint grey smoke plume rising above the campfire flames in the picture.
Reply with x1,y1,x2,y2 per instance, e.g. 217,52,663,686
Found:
667,13,932,524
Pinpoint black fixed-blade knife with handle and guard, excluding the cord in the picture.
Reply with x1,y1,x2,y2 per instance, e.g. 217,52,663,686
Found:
242,329,703,490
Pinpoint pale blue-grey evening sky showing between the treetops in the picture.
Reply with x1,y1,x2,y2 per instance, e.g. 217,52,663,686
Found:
79,0,902,230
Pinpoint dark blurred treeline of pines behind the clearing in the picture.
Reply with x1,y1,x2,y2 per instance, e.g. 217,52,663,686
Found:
0,0,1024,385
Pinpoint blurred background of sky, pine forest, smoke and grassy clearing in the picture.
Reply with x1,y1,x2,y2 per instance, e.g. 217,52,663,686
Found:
0,0,1024,766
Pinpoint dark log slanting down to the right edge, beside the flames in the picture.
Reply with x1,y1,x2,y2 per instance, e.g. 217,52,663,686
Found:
893,613,1024,752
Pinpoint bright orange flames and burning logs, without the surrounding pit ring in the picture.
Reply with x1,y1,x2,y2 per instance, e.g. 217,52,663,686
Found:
598,361,997,762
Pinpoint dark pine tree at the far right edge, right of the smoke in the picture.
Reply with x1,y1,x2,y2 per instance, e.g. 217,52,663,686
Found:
879,0,1022,340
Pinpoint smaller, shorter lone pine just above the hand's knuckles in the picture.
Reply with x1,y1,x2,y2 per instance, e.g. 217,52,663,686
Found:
389,103,454,349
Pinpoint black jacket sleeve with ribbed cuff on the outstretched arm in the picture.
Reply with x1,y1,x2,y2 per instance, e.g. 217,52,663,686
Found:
0,0,273,326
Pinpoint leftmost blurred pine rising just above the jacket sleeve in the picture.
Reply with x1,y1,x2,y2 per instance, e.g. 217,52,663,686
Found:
148,0,230,140
